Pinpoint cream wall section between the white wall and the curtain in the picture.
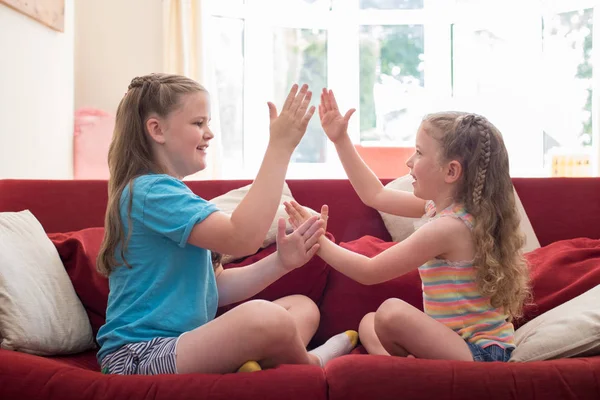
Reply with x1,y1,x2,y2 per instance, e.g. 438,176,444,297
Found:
75,0,163,113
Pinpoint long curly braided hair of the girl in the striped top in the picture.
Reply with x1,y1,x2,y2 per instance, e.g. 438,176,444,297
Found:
423,112,530,320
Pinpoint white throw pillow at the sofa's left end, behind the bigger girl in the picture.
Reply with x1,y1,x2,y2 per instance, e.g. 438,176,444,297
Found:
0,210,94,356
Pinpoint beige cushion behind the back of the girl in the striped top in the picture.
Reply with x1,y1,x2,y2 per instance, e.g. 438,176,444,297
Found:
379,175,540,253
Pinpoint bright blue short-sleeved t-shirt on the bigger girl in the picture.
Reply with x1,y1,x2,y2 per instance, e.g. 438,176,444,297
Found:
97,174,218,361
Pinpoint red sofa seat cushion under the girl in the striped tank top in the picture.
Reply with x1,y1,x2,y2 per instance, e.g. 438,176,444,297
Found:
325,355,600,400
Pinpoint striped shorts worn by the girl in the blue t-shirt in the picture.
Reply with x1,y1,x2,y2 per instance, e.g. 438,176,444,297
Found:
101,337,179,375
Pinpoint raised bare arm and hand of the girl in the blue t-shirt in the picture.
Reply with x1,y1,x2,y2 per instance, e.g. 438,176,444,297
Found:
188,85,315,256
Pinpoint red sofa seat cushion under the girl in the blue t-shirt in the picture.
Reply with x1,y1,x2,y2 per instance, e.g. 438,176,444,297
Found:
0,350,327,400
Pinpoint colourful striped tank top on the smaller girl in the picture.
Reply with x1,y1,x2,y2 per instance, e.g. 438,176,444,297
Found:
419,201,514,348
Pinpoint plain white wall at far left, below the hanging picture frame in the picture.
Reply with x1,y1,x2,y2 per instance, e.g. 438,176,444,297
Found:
0,0,74,179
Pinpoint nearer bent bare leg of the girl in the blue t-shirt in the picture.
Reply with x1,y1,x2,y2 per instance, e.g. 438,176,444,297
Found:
176,300,319,374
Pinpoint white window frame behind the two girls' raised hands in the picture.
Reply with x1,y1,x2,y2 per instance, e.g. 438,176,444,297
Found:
206,0,600,179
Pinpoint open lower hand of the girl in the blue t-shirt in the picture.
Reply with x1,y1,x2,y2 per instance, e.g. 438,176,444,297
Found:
277,216,325,271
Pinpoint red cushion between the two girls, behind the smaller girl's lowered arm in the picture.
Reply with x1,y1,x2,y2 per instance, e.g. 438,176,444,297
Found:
314,236,423,344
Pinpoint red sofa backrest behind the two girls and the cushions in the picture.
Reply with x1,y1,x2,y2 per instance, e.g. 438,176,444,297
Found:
0,178,600,246
